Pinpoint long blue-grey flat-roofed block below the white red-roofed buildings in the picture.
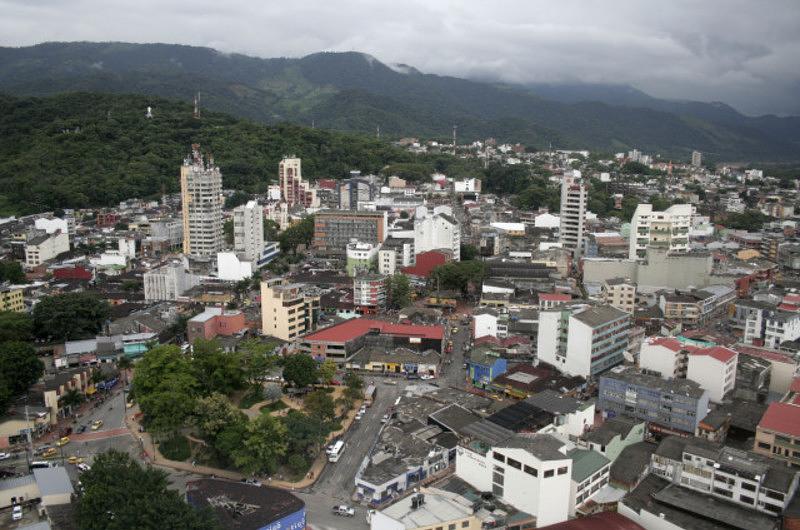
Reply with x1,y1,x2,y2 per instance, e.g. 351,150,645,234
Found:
598,367,708,436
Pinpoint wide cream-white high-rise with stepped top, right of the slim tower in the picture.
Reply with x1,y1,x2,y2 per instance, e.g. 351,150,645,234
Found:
628,204,692,259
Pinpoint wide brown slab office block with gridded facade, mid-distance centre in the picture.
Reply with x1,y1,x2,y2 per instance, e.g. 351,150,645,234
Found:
312,210,388,256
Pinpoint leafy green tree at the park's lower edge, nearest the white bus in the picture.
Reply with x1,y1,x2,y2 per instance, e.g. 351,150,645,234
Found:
233,414,287,475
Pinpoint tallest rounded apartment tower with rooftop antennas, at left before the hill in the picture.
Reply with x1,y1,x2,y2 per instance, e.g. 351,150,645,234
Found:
181,144,224,257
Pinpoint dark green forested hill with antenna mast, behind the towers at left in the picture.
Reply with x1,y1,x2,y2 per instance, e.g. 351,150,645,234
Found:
0,93,416,214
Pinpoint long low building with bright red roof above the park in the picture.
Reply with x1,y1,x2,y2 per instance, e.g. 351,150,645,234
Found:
297,318,444,362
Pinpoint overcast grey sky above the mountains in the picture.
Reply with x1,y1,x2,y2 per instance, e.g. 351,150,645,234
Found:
0,0,800,115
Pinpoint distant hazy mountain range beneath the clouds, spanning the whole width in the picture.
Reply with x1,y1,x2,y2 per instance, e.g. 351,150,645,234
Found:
0,42,800,161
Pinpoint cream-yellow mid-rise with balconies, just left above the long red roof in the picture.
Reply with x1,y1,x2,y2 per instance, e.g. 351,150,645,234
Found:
261,278,320,341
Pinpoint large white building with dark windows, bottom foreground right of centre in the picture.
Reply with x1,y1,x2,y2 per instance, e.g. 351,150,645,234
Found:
456,434,572,527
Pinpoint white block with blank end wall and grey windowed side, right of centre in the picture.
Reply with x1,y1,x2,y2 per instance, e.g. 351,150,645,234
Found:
537,304,631,378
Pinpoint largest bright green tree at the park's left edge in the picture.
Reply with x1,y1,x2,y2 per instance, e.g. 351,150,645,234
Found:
133,345,200,434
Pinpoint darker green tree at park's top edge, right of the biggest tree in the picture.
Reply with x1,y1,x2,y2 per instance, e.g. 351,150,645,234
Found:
192,339,245,395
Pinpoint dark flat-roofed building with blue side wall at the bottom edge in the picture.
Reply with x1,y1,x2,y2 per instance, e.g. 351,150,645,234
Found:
186,478,306,530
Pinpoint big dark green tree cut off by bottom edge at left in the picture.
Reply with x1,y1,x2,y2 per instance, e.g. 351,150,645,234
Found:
77,449,217,530
